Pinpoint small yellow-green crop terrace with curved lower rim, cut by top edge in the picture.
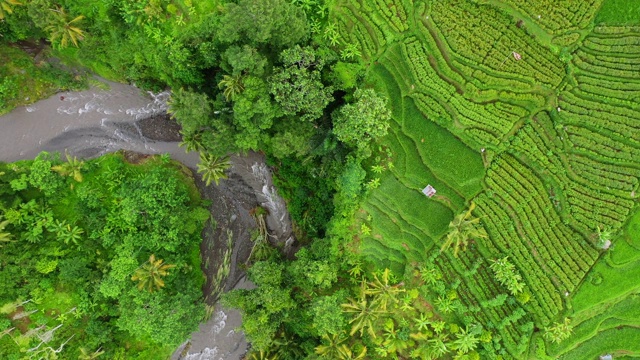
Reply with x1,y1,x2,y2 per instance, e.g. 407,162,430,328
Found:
506,0,602,34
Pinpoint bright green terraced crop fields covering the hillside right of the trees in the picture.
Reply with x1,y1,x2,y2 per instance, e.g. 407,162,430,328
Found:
332,0,640,359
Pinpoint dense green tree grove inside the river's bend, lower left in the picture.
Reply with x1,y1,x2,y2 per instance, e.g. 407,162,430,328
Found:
0,153,209,359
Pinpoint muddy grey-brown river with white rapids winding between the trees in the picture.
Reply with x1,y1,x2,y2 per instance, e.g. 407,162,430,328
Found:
0,80,294,360
